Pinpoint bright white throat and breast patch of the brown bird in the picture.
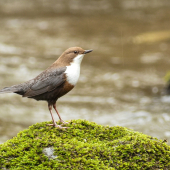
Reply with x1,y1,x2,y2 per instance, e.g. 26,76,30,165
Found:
65,54,84,86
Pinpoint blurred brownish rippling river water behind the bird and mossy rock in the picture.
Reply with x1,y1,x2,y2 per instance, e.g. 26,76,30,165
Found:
0,0,170,143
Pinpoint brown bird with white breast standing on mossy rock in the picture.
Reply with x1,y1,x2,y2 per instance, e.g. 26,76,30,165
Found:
0,47,93,129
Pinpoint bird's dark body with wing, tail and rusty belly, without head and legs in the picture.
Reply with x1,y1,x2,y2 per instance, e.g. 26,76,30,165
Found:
0,67,74,101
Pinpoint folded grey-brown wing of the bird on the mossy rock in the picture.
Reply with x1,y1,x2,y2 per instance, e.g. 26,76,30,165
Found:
23,67,66,97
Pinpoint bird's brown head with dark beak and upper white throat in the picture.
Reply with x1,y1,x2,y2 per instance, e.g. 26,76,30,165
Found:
55,47,93,66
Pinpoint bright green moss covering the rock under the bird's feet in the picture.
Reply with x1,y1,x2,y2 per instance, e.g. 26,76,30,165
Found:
0,120,170,170
